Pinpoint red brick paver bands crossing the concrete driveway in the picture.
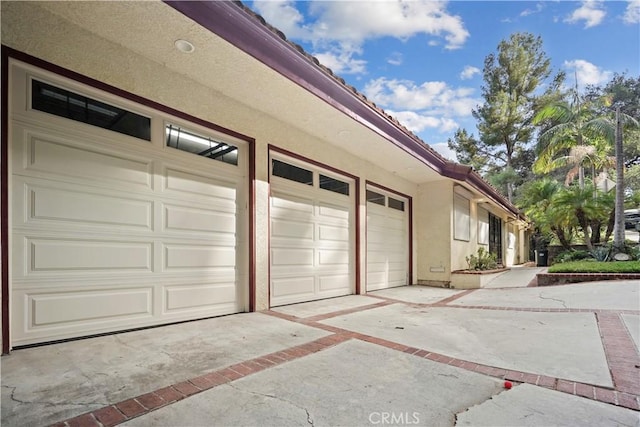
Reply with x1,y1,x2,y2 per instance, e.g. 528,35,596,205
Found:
54,289,640,427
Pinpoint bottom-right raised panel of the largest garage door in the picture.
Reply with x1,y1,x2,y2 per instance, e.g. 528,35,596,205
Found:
165,281,236,312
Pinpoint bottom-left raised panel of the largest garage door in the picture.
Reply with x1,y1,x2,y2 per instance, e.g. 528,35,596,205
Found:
24,287,153,329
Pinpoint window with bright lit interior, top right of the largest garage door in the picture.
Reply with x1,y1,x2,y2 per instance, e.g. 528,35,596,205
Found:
165,124,238,166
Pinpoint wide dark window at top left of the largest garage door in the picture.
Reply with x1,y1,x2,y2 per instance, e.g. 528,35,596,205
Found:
31,80,151,141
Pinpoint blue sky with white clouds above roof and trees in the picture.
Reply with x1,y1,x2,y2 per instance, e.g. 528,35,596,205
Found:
246,0,640,158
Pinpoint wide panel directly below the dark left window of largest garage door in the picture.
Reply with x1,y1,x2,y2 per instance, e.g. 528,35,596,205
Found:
14,133,153,188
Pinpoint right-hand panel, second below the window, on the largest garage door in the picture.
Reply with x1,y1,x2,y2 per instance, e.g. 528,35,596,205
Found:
163,204,237,239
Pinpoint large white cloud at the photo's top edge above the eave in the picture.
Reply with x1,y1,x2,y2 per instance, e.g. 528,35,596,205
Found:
252,0,469,73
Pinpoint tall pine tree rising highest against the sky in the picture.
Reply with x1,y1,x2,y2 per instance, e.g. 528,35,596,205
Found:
473,33,564,201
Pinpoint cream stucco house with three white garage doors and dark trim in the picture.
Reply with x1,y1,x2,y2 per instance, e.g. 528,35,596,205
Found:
1,1,528,352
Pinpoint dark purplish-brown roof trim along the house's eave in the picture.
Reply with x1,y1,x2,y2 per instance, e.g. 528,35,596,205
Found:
165,0,519,215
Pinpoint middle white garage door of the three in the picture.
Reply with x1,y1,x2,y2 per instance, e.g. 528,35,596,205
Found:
270,158,355,306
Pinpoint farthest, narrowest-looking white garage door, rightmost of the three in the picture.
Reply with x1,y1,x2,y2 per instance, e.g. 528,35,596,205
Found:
367,187,409,291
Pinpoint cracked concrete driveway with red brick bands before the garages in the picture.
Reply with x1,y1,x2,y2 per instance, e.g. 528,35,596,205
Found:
1,276,640,426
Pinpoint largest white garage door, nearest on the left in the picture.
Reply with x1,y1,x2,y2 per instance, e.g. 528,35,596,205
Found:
10,64,248,346
